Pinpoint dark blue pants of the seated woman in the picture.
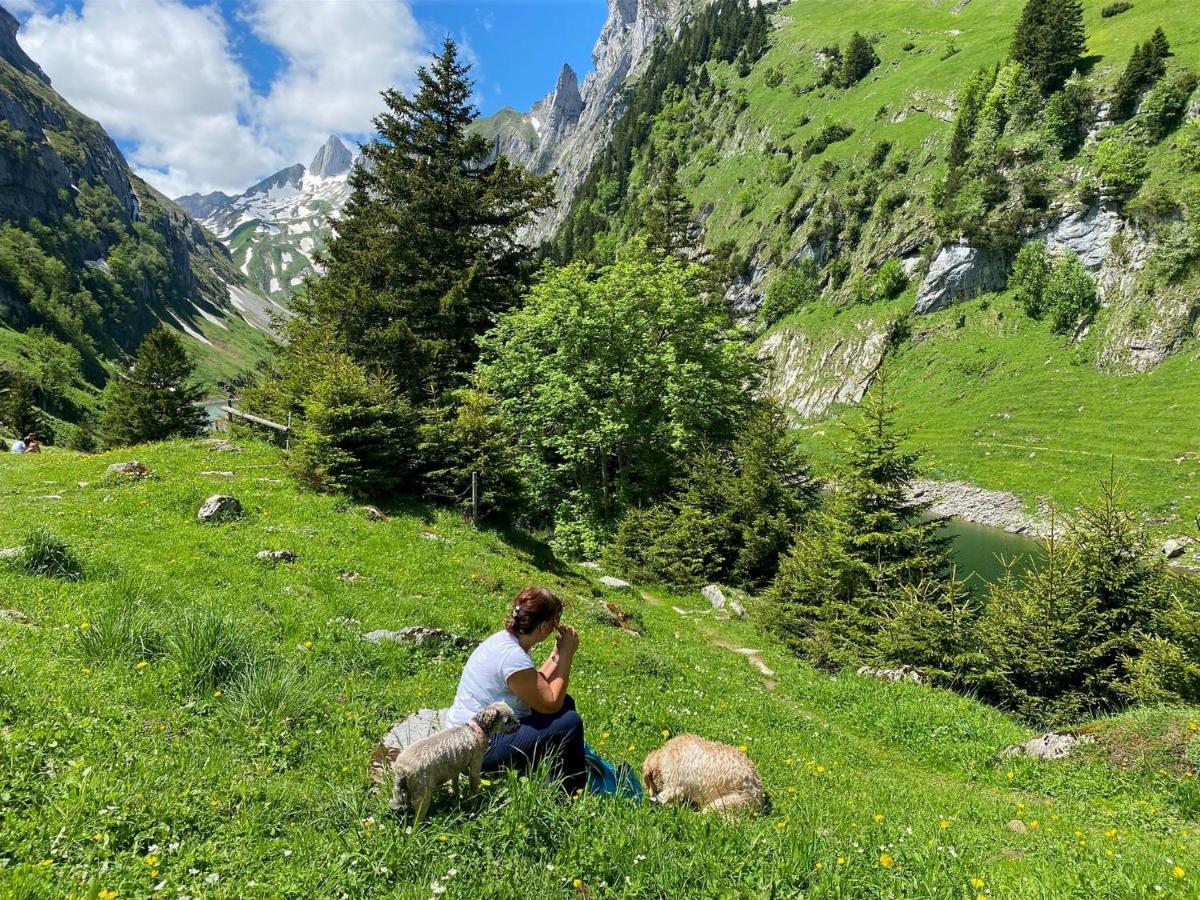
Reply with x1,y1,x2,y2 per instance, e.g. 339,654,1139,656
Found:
484,694,587,794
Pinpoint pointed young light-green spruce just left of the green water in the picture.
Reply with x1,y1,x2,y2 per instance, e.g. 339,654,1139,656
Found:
763,383,949,667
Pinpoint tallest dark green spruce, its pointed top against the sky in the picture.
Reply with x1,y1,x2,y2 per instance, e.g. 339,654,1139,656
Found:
289,38,552,407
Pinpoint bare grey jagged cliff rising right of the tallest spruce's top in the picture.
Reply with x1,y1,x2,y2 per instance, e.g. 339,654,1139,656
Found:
479,0,694,241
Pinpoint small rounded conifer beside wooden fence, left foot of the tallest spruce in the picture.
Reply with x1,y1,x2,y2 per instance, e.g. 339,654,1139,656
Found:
292,353,417,496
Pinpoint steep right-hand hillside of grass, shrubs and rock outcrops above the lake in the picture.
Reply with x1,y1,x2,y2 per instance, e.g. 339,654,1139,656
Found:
547,0,1200,529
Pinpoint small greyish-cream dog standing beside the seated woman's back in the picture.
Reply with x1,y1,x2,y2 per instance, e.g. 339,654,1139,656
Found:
390,703,521,824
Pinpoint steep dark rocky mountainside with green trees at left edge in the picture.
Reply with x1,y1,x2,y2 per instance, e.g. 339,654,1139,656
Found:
0,8,270,437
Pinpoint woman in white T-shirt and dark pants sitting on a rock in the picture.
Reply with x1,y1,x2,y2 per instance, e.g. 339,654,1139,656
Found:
445,588,587,794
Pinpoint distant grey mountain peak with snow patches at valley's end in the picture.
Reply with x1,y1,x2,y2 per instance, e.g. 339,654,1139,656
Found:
176,136,354,308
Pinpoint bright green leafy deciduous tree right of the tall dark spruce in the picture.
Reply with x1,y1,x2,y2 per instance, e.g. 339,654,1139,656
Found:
479,241,757,552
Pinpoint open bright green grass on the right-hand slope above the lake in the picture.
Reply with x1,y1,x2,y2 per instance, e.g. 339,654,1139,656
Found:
656,0,1200,530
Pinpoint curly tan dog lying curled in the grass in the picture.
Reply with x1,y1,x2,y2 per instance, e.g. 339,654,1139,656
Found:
642,734,763,812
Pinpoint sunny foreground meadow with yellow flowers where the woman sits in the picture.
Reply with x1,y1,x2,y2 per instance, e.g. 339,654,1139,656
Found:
0,444,1200,898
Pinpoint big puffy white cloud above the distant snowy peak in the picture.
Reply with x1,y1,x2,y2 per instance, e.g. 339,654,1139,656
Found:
16,0,422,196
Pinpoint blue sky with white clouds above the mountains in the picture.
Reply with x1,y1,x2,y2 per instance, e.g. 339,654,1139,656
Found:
12,0,607,197
